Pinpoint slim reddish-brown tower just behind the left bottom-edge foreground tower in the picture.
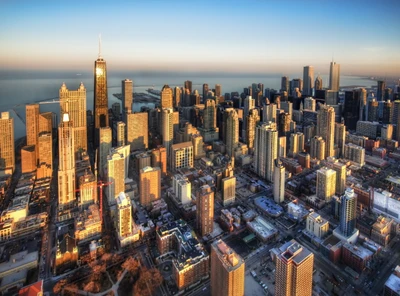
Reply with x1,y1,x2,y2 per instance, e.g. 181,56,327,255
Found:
196,185,214,237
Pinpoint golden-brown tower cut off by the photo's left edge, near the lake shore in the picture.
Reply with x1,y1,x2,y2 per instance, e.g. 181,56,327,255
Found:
0,112,15,172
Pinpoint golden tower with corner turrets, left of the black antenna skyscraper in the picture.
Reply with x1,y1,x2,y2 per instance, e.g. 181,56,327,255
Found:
59,83,87,153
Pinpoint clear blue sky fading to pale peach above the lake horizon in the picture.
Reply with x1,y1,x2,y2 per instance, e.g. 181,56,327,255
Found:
0,0,400,75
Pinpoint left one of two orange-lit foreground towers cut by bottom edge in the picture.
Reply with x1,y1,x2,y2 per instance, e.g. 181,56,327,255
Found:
211,240,245,296
